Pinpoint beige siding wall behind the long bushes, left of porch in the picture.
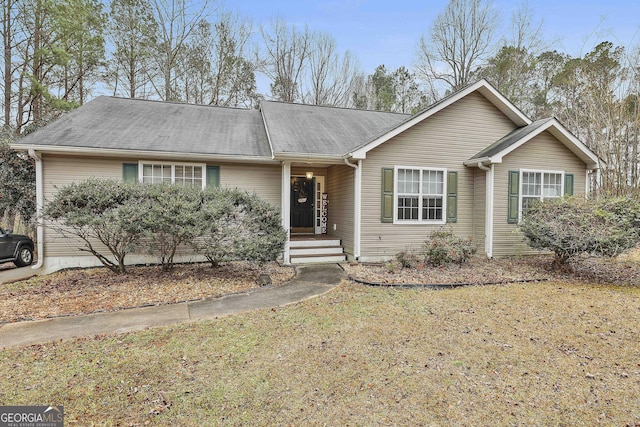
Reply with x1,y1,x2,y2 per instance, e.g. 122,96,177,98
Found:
42,154,281,257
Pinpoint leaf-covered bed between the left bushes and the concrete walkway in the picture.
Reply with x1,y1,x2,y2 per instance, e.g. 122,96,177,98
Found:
0,262,294,322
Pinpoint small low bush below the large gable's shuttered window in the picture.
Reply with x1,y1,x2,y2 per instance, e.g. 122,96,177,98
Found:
423,230,476,266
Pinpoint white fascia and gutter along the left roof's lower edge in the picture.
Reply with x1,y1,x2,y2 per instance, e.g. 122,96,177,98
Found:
11,143,279,164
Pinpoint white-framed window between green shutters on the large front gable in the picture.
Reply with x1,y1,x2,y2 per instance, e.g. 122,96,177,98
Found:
394,167,446,223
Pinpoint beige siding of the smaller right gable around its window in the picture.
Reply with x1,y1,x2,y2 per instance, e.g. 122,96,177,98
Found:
493,132,587,257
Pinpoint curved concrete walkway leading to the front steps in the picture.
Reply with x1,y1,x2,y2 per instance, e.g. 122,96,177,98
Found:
0,264,344,348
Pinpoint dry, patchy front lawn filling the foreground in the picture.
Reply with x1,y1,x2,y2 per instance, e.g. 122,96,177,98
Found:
0,254,640,426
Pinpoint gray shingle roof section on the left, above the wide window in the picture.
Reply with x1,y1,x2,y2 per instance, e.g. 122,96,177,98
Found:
18,96,271,157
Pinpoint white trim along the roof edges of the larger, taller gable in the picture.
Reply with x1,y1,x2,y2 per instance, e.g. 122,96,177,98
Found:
344,79,531,159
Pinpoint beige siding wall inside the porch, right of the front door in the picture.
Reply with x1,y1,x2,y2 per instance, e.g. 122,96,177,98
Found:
327,165,355,255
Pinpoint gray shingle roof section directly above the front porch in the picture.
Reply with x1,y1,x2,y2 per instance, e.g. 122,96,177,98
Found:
260,101,410,156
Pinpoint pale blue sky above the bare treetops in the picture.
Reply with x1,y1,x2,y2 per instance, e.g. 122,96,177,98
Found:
230,0,640,74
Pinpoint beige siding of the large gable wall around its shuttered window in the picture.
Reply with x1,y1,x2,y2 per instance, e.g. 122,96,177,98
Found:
361,93,515,259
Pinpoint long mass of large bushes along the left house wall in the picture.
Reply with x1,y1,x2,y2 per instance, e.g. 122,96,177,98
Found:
45,178,286,273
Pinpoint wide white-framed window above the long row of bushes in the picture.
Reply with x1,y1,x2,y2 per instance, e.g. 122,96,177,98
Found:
138,162,206,188
